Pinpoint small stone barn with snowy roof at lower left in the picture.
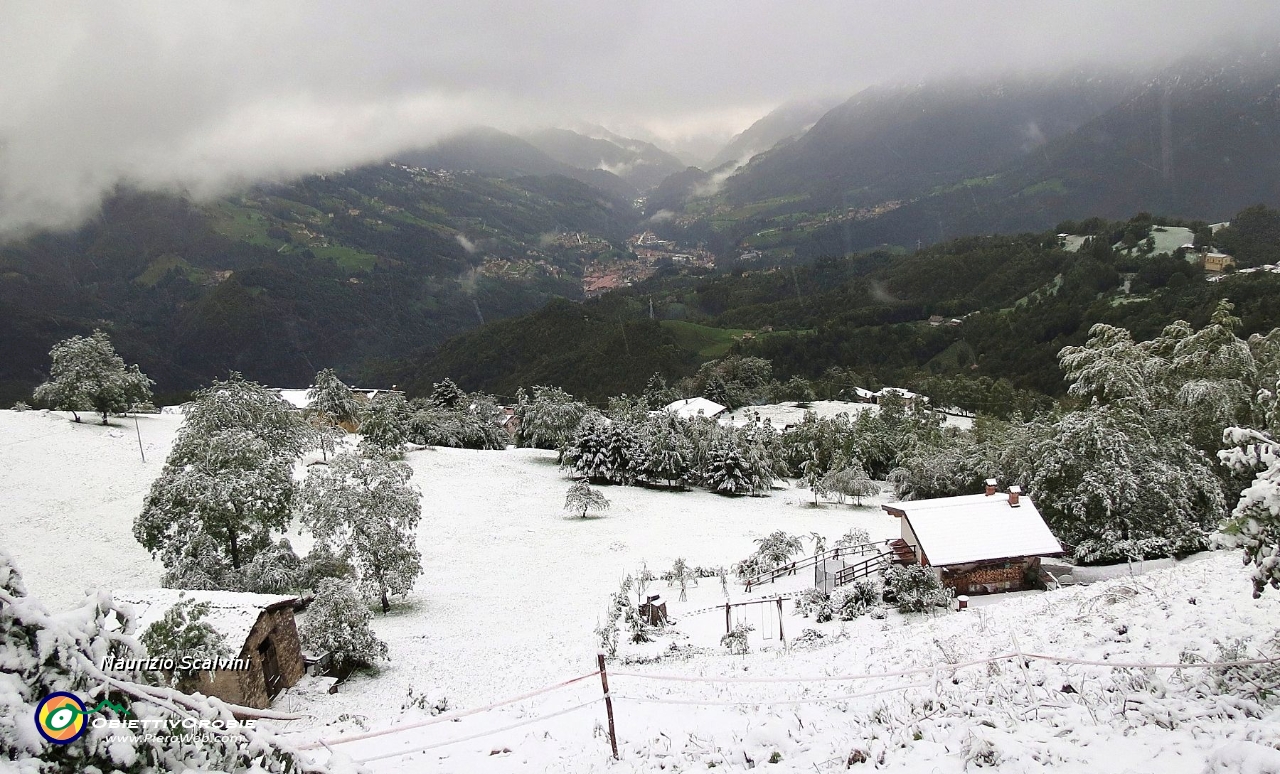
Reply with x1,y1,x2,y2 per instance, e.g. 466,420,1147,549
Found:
120,588,306,709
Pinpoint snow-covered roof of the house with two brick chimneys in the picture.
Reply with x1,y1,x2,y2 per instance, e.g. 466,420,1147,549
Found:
883,493,1062,565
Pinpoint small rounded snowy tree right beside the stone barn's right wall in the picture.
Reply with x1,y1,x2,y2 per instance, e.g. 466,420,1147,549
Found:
298,578,387,675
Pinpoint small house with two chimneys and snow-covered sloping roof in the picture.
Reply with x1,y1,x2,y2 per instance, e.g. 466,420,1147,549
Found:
883,480,1064,595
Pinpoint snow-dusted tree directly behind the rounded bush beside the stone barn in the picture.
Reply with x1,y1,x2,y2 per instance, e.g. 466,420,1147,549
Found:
297,454,422,613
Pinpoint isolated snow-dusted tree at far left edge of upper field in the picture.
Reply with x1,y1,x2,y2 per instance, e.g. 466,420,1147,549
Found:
35,330,154,425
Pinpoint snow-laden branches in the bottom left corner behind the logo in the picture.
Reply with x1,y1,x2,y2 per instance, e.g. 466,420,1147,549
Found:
0,551,345,774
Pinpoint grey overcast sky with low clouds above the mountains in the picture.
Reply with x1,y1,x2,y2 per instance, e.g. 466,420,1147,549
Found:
0,0,1280,233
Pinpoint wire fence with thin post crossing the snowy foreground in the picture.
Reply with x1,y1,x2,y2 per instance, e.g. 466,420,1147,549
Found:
300,640,1280,764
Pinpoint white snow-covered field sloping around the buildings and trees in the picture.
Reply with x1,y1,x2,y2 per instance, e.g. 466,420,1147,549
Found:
0,412,1280,774
